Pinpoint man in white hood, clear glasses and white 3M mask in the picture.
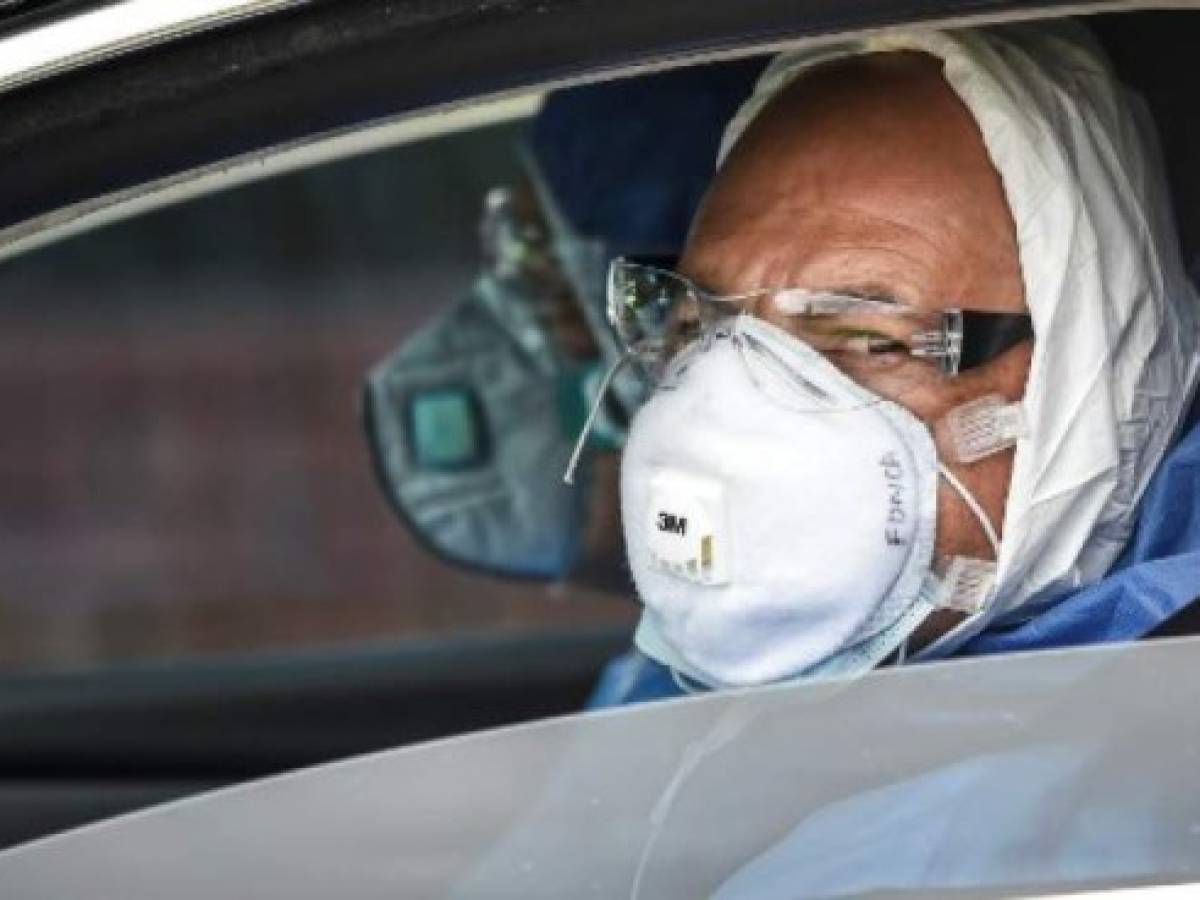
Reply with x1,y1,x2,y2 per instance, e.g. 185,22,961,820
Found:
594,24,1200,706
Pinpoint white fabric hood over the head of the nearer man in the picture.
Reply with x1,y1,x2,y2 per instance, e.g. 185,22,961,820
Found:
719,23,1200,655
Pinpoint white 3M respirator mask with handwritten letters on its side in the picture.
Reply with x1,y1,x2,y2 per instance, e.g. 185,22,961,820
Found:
620,314,990,688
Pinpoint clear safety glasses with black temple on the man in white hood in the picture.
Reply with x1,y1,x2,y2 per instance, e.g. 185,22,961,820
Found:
607,258,1033,377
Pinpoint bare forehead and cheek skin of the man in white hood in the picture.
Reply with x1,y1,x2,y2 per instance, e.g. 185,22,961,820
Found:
679,52,1032,647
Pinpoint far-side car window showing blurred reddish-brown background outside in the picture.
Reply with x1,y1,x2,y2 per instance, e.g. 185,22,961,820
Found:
0,103,632,670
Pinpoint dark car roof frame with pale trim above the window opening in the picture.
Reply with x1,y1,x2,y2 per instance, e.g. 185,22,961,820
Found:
0,0,1146,263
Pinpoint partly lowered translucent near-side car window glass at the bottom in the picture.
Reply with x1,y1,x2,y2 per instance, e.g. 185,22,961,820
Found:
0,638,1200,900
